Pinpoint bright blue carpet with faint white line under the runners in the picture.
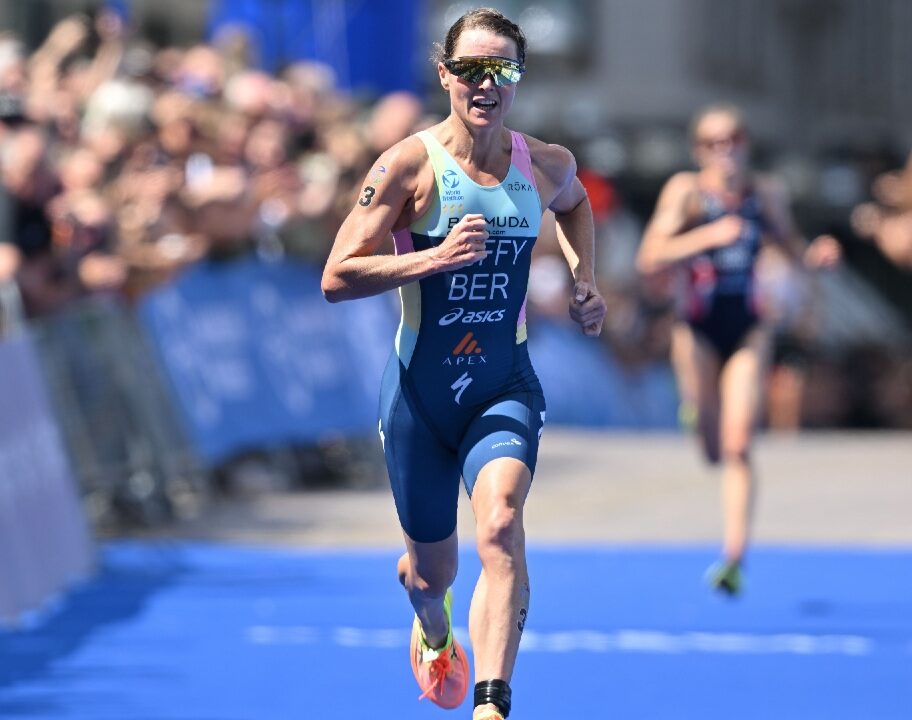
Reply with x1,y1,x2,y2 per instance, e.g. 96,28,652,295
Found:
0,543,912,720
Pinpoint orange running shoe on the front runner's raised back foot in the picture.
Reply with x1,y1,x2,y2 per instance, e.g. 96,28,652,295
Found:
409,590,469,710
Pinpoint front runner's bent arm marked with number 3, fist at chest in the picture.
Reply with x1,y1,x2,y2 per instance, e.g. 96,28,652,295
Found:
322,138,488,302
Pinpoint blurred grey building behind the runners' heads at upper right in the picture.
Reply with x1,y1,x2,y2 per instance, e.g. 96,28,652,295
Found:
420,0,912,152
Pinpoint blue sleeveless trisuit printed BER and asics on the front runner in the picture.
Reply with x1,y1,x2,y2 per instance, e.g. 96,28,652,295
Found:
380,131,545,542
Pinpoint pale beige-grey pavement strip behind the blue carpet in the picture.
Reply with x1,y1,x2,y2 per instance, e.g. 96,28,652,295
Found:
144,428,912,548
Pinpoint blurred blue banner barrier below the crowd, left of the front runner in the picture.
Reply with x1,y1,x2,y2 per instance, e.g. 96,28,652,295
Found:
139,258,396,463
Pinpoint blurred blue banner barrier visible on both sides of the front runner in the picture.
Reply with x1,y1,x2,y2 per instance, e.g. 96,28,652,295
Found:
139,257,677,463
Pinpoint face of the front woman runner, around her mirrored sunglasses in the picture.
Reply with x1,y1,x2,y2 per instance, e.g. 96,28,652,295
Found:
437,28,518,127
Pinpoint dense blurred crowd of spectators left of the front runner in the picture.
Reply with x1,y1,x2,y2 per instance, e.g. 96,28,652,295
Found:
0,9,432,318
